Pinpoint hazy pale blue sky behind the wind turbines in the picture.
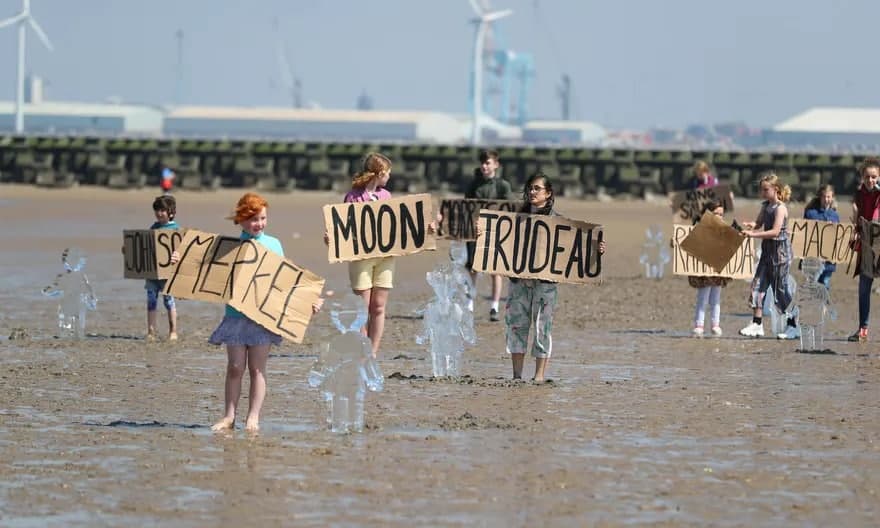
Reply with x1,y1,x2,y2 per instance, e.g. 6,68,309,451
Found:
0,0,880,129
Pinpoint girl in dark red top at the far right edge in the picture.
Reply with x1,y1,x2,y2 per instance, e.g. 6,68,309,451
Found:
847,158,880,343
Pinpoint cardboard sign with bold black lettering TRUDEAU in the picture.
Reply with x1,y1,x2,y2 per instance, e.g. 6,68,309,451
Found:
473,210,603,284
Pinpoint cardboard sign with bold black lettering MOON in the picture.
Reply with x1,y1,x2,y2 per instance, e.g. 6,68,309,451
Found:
324,194,437,262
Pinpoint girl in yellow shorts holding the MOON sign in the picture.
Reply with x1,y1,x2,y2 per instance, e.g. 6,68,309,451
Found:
344,152,394,357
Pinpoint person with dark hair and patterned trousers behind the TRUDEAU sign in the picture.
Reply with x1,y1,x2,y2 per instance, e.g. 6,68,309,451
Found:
504,172,605,381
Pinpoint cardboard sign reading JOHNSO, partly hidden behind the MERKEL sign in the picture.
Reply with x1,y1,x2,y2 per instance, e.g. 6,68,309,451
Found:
122,229,186,279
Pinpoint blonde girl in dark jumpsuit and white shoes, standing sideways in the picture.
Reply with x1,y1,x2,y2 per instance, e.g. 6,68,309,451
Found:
739,172,800,339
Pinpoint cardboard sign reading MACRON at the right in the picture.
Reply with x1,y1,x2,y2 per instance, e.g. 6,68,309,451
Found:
788,219,856,268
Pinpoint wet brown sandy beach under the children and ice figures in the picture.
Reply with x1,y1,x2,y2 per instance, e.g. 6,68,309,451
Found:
0,186,880,527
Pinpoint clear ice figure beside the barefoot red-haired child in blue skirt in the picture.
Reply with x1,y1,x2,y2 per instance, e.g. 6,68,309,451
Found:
309,293,385,433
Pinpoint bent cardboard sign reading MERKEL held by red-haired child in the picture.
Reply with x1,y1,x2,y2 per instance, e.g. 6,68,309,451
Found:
163,229,324,343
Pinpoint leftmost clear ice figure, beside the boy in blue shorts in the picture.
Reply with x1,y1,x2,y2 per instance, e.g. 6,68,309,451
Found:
42,248,98,339
